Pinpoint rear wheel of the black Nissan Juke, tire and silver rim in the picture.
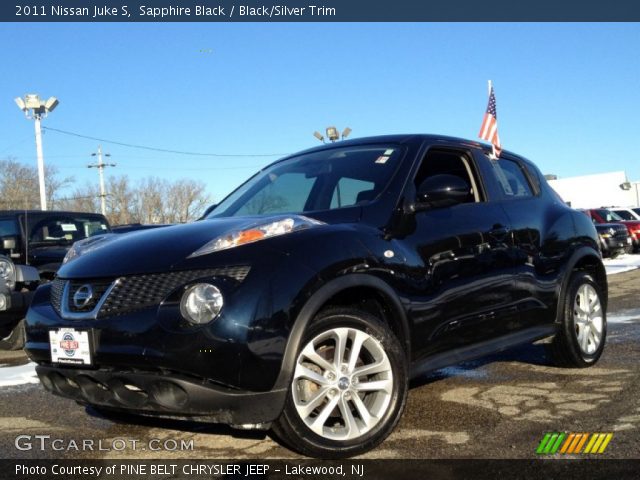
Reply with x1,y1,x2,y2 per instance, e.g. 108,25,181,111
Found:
549,271,607,368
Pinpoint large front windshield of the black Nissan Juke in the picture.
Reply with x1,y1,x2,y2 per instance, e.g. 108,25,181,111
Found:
207,145,403,218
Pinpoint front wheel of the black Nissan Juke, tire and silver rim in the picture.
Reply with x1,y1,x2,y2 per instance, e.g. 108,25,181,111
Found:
272,308,408,459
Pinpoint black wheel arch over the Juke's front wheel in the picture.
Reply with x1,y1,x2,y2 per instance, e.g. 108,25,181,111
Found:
274,274,411,388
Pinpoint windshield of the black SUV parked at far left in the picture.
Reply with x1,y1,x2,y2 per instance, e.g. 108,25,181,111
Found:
29,215,109,245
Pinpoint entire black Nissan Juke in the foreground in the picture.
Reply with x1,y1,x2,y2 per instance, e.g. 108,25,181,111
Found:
26,135,607,457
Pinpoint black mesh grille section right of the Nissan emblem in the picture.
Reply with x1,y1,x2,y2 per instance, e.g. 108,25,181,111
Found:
98,266,250,318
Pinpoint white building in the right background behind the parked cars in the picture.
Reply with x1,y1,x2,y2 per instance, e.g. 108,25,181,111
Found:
549,171,640,208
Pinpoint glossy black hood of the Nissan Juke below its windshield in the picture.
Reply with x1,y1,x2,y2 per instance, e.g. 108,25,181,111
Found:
58,215,283,278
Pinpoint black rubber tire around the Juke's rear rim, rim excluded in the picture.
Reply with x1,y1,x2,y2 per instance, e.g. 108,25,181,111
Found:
562,272,607,366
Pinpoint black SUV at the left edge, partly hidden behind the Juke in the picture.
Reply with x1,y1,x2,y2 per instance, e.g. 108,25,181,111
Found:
0,210,109,349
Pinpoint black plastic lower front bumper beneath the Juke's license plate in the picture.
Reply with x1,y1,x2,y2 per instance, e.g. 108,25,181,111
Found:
36,365,287,425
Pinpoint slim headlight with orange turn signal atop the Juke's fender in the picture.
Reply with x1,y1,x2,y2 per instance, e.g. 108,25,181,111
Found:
189,215,324,258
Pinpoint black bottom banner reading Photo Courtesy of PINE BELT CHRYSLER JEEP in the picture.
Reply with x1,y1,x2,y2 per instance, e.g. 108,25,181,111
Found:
0,459,640,480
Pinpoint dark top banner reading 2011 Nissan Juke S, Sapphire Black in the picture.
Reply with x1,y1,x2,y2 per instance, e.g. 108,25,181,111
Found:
0,0,640,22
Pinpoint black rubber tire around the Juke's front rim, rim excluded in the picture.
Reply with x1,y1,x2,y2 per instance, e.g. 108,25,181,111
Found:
279,309,408,458
